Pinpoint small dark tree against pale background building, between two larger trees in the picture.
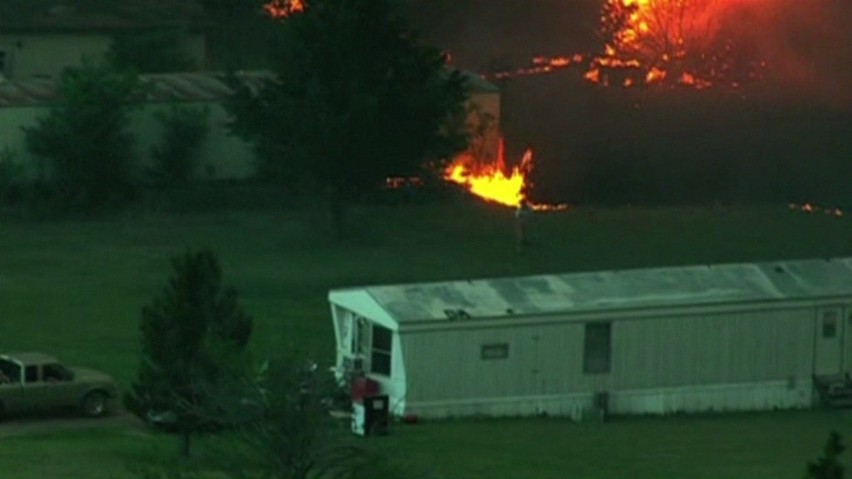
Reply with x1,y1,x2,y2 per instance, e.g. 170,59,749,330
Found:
151,106,210,186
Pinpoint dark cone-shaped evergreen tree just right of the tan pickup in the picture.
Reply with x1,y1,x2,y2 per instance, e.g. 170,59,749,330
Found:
125,250,252,456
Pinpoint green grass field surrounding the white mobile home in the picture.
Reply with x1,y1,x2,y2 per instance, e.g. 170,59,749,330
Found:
0,201,852,479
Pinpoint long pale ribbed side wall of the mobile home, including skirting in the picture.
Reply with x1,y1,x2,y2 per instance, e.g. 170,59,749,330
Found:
402,307,815,417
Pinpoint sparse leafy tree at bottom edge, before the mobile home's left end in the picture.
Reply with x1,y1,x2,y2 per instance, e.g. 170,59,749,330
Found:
202,357,356,479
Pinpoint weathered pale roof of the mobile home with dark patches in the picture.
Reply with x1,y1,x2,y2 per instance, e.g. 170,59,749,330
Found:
329,258,852,323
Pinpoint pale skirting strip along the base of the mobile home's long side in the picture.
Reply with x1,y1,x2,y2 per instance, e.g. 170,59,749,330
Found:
405,380,813,420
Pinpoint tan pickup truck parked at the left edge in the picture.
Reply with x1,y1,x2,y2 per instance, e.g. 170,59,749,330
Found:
0,352,117,417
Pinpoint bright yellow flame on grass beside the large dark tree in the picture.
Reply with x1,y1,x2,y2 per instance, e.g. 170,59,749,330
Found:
444,139,568,211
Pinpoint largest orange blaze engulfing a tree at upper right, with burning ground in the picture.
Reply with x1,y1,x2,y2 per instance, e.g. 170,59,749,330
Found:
486,0,766,90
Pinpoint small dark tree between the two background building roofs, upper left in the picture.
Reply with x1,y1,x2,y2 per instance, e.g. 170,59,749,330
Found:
107,28,197,73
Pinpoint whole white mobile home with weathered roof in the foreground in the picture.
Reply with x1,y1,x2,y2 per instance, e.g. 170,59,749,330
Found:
329,258,852,418
